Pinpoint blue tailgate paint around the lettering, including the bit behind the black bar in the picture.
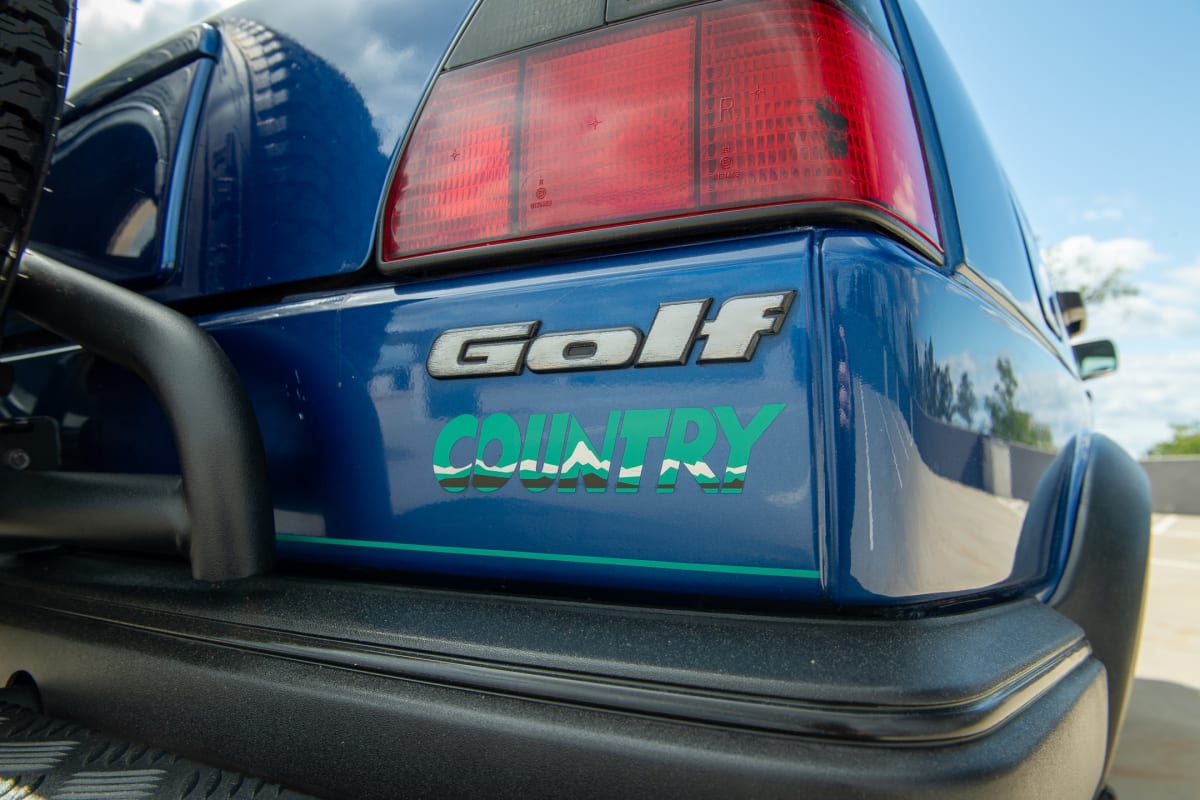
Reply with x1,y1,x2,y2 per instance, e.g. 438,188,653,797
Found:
14,233,821,600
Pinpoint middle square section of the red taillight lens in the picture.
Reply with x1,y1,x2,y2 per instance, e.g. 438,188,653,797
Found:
517,17,696,233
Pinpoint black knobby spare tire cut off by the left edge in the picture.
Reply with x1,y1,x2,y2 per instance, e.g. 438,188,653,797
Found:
0,0,74,326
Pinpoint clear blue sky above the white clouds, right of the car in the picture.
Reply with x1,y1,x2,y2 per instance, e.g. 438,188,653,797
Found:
923,0,1200,258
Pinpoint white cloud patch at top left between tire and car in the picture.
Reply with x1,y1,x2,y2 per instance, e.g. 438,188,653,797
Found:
71,0,236,89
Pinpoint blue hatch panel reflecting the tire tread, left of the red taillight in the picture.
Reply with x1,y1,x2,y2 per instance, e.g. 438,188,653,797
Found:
150,0,473,301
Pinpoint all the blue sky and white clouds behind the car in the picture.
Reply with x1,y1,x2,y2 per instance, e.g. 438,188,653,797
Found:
72,0,1200,456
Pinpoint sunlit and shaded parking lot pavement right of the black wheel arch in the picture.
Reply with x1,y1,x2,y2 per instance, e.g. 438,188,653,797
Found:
1110,515,1200,800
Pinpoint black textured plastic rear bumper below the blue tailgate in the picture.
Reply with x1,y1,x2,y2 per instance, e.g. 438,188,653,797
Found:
0,557,1106,798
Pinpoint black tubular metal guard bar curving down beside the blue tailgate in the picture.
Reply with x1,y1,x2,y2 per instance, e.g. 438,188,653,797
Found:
0,252,275,582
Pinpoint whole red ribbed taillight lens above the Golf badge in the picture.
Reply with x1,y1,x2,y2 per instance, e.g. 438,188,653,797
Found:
384,0,936,260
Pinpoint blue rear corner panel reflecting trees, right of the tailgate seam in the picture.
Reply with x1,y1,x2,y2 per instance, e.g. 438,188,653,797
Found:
822,231,1090,602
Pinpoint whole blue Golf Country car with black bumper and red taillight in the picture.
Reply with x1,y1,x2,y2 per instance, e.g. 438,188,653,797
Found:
0,0,1150,798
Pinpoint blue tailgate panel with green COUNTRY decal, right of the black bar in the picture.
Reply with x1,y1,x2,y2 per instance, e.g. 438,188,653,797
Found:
218,227,820,599
